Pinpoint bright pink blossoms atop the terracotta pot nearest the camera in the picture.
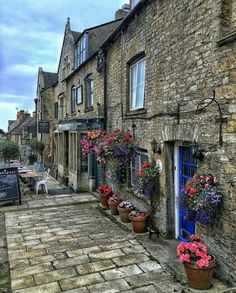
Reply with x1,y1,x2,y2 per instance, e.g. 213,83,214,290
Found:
177,235,212,268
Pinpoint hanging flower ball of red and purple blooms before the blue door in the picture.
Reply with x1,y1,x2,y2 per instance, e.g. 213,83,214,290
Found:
179,174,222,225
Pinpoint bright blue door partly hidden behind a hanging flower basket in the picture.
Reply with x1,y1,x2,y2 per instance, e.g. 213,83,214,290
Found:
178,146,197,241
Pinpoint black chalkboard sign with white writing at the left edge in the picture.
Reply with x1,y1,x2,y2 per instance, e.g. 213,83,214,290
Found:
0,167,21,204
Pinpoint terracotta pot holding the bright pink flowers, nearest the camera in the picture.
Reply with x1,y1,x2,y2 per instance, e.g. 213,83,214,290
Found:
184,257,215,290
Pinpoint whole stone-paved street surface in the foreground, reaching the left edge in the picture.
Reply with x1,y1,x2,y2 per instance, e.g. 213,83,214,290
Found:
0,178,233,293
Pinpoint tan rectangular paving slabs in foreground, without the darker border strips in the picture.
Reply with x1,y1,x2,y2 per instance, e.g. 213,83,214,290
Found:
5,204,169,293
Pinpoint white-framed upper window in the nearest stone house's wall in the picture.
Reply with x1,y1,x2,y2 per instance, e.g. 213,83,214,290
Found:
130,58,145,110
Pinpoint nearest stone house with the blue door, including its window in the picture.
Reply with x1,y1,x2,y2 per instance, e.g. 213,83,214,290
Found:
97,0,236,284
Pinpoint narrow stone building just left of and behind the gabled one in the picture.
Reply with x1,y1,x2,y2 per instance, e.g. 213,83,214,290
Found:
34,67,57,167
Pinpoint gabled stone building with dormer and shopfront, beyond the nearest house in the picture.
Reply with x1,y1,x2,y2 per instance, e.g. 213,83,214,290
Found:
54,11,125,191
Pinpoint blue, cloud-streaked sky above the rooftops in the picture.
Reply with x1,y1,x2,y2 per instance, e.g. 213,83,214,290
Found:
0,0,129,131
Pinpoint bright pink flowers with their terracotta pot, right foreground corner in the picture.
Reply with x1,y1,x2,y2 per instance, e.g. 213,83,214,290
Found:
177,235,215,290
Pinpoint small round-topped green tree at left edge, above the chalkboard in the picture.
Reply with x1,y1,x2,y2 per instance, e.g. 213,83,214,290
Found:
0,140,20,166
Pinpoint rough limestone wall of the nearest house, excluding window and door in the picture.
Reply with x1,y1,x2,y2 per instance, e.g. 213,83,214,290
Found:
107,0,236,283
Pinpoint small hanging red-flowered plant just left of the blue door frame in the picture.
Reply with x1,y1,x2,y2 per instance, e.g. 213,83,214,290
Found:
137,162,160,196
